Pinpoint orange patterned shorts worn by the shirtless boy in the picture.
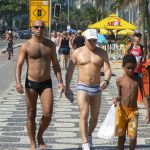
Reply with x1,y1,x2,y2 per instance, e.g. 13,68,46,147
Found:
115,104,138,138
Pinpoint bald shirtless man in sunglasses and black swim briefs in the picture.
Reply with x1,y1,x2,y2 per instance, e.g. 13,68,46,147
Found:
16,20,64,150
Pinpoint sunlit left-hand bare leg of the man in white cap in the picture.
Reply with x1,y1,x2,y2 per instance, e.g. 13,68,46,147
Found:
77,91,89,143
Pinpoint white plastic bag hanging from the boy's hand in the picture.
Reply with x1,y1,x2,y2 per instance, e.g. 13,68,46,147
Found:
97,104,116,140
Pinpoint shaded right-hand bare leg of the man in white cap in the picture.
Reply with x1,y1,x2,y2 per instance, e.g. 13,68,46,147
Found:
88,93,101,136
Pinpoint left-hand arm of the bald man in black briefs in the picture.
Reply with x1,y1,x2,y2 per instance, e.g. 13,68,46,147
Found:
15,44,26,94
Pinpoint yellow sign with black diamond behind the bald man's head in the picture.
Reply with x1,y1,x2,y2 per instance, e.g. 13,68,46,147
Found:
29,0,50,27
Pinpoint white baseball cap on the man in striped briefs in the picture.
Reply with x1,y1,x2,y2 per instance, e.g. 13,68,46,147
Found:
84,29,98,40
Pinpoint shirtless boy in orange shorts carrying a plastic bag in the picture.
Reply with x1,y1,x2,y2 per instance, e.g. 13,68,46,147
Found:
114,54,150,150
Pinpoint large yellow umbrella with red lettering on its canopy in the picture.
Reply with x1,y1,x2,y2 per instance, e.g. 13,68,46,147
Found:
89,14,137,30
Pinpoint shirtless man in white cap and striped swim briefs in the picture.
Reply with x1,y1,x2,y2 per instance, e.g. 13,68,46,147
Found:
65,29,111,150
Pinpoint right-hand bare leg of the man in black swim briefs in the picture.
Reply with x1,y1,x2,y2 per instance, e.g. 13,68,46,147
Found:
37,88,53,148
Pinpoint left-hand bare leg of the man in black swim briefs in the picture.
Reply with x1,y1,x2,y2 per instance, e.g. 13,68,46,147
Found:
26,88,38,150
